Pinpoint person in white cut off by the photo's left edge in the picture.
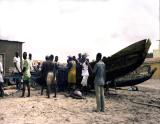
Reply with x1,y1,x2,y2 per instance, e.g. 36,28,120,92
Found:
0,62,4,97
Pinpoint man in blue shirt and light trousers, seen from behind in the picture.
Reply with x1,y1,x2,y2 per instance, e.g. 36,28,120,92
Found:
93,53,105,112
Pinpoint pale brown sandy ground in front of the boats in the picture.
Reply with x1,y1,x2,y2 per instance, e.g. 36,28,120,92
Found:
0,79,160,124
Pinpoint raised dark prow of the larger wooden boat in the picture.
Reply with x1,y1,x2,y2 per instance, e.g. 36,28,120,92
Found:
88,39,155,86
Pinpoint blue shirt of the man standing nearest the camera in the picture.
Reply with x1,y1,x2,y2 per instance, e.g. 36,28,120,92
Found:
93,60,106,85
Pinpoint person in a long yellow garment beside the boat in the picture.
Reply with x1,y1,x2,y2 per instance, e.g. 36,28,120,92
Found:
67,57,76,93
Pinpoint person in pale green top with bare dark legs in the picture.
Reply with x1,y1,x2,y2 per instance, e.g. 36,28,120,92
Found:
21,52,31,97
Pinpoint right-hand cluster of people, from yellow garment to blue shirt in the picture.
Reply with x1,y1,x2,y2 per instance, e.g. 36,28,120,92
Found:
63,53,106,112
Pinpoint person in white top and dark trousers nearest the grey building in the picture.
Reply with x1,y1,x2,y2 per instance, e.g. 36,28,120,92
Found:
13,52,22,90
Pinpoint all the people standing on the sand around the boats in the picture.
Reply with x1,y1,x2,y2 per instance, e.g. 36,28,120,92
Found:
0,52,106,112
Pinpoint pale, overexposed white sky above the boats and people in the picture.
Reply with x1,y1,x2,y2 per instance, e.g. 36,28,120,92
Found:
0,0,160,62
